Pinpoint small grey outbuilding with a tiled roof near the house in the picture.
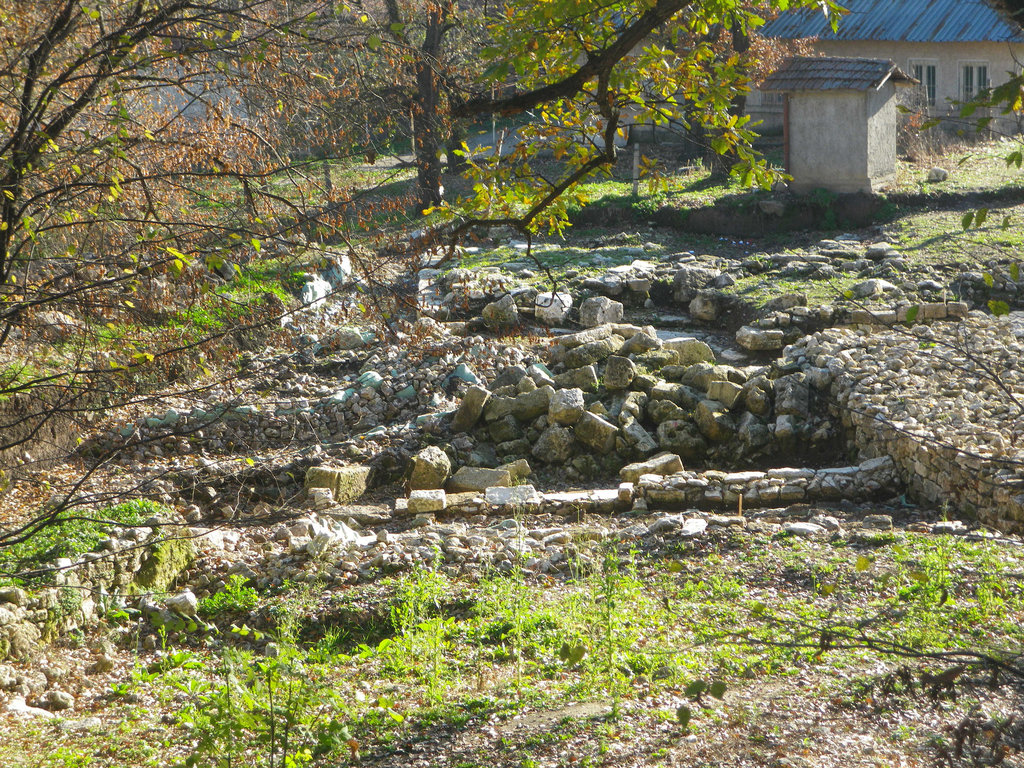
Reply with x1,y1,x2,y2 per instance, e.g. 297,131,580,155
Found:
761,57,916,193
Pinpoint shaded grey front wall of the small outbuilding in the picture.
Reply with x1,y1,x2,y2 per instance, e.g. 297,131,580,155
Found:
788,90,868,193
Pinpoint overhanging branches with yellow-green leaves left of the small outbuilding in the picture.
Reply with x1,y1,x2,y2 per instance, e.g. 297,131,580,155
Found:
450,0,839,240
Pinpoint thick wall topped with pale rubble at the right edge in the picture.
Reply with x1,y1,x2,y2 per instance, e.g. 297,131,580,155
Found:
786,312,1024,531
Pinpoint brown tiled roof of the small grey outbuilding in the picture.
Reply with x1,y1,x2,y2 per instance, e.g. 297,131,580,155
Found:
760,56,918,91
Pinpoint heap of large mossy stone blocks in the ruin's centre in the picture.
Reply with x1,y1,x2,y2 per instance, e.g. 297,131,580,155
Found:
452,319,837,480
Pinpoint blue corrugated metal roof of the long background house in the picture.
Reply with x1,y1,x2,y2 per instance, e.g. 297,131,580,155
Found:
761,0,1024,43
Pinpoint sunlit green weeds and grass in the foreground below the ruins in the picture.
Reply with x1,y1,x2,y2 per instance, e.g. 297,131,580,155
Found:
0,520,1024,768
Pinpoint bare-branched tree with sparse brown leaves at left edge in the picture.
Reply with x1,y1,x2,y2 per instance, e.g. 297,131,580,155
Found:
0,0,366,557
